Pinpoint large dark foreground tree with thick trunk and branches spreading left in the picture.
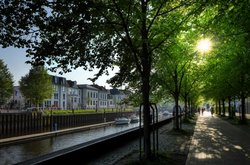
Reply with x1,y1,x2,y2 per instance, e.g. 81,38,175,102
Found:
0,0,210,158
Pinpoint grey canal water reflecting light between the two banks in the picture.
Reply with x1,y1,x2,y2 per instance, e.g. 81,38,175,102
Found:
0,114,171,165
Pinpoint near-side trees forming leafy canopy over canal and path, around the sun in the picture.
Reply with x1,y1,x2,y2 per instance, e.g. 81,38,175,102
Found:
0,0,250,158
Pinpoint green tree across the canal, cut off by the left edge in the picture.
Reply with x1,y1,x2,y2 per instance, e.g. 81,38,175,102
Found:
0,59,14,106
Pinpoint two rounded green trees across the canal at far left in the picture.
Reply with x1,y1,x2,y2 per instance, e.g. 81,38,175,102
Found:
0,59,53,108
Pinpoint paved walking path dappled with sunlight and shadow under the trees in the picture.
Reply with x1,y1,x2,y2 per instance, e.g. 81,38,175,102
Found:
186,112,250,165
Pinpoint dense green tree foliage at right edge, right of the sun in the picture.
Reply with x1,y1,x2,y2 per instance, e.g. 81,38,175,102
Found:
198,0,250,122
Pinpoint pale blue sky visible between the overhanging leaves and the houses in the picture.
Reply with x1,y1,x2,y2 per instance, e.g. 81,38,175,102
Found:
0,47,118,89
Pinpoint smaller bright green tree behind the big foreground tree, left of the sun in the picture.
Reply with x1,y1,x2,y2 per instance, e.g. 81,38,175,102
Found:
155,32,200,130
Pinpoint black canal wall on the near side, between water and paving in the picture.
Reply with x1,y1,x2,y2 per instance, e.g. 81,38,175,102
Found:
19,118,172,165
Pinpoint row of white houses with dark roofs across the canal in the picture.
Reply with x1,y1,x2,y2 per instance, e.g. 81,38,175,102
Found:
9,76,130,110
